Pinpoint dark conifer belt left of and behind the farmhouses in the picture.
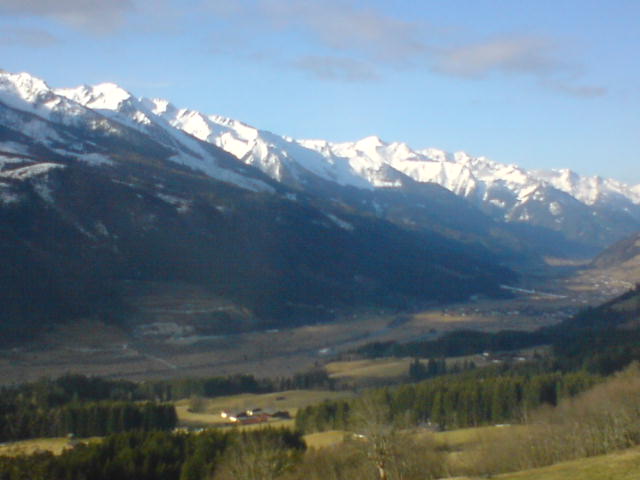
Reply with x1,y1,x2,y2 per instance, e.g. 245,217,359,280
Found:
0,369,333,441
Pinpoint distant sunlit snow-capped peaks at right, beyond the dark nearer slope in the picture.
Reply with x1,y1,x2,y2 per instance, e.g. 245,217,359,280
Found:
302,137,640,245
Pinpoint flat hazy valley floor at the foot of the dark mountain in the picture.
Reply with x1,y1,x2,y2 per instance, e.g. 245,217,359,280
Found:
0,255,632,384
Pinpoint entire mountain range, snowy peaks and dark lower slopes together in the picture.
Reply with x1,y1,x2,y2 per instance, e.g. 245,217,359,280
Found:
0,72,640,342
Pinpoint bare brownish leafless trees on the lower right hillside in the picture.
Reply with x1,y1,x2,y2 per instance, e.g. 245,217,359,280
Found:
455,363,640,478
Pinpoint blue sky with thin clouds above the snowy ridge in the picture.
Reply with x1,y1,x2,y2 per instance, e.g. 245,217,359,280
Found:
0,0,640,183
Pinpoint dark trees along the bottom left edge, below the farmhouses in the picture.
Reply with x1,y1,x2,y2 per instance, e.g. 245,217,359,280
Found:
0,429,306,480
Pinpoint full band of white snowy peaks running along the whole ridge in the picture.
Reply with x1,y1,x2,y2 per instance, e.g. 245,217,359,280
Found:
0,74,640,253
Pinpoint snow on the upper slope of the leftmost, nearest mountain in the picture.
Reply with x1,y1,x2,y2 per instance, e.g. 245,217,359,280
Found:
0,72,274,191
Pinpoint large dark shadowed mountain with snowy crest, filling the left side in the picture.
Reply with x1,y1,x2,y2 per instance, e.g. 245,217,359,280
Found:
0,72,514,341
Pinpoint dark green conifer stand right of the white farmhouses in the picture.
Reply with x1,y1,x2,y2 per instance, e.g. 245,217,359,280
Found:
296,369,601,433
